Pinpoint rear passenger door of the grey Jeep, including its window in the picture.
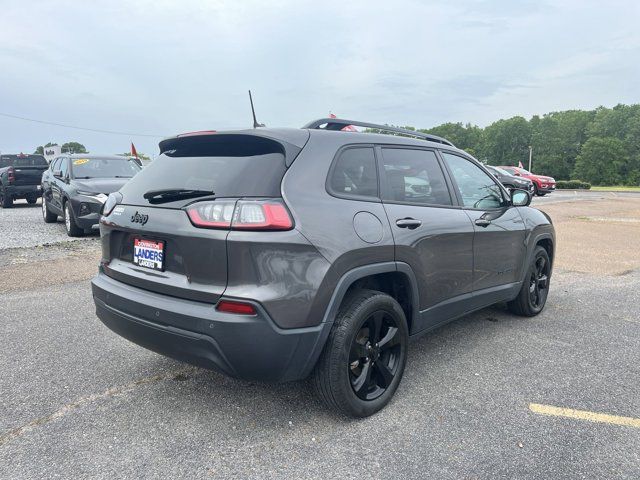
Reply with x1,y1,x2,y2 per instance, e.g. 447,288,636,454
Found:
378,147,474,333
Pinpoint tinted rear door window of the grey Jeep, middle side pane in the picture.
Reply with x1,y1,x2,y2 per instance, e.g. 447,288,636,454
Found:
382,148,452,205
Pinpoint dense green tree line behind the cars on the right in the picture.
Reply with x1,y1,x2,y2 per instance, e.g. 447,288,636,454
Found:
407,104,640,185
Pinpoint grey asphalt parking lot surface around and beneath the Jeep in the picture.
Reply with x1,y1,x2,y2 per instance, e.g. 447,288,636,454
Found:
0,194,640,479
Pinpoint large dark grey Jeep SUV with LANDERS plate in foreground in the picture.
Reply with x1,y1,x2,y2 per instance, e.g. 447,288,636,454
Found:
92,119,555,416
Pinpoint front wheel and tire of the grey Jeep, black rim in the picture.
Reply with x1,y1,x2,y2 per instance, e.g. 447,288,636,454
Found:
508,246,551,317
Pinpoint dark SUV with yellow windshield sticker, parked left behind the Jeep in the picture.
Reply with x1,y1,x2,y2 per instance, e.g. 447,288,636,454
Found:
42,154,140,237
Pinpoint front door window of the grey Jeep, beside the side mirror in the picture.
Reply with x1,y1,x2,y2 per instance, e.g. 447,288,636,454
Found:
442,152,504,209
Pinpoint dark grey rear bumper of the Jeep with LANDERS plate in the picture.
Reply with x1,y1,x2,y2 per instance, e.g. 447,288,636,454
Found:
91,272,331,382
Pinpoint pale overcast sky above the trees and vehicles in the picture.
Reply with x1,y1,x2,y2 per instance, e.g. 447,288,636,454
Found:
0,0,640,154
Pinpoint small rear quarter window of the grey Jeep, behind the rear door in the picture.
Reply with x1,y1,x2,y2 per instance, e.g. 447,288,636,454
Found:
330,147,378,197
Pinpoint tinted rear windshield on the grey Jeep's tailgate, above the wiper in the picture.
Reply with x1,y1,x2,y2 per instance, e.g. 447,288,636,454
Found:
121,135,286,204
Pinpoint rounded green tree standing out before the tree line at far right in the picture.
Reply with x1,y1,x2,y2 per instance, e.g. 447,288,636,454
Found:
573,137,629,185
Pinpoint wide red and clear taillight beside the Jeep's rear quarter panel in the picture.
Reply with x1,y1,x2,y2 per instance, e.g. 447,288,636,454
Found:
186,199,293,230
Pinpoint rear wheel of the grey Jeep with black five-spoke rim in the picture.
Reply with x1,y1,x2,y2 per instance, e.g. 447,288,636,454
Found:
312,290,409,417
